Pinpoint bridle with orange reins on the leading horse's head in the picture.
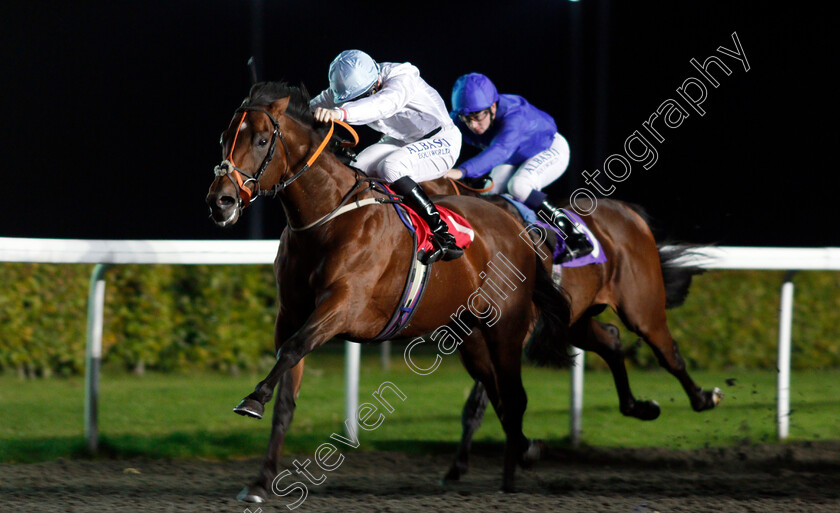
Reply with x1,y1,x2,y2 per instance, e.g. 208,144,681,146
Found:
213,100,359,208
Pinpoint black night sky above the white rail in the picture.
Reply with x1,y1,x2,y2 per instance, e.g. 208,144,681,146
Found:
0,0,840,246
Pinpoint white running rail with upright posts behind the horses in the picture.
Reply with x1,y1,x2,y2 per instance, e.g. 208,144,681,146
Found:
0,237,840,450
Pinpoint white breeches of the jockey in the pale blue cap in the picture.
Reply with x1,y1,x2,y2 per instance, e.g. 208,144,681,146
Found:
353,125,461,183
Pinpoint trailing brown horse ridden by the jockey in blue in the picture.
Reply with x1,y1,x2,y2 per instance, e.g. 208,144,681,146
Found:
423,179,723,481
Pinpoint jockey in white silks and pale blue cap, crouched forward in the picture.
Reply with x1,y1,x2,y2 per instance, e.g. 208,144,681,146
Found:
309,50,464,263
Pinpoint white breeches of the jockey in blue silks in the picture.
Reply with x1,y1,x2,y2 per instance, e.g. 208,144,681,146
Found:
490,134,569,201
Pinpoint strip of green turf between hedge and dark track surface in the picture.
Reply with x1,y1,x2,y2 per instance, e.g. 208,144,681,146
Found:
0,347,840,462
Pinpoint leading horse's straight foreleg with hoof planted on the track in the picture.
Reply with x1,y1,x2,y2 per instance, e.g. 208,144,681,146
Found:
237,359,304,503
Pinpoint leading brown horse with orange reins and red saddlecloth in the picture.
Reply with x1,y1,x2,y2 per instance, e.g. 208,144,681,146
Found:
206,83,569,502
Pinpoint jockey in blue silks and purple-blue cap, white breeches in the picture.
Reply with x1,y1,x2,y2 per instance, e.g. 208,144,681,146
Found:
447,73,593,263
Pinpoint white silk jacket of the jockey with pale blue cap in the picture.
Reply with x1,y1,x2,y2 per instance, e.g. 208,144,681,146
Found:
309,62,454,143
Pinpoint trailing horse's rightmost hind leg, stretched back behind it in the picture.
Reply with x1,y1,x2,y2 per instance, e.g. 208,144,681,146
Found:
618,301,723,412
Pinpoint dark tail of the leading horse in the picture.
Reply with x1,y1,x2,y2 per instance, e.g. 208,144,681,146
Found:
525,256,571,367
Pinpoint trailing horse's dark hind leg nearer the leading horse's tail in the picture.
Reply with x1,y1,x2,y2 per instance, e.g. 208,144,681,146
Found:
571,317,660,420
